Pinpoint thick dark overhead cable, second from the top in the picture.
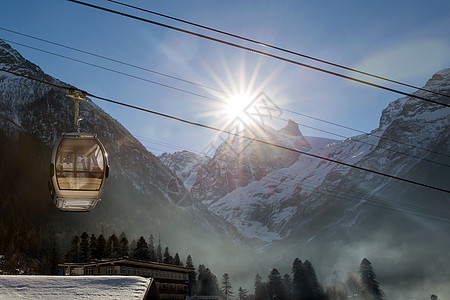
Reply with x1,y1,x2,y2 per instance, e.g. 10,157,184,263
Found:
67,0,450,107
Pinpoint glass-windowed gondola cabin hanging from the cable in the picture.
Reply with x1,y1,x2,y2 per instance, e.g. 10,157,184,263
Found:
49,132,109,211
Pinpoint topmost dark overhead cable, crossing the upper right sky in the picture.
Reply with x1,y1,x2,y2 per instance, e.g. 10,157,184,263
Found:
106,0,450,98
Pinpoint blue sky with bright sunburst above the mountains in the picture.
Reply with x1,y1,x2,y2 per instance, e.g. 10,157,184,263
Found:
0,0,450,154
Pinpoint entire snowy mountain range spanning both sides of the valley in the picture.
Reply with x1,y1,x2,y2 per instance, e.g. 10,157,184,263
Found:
0,41,450,296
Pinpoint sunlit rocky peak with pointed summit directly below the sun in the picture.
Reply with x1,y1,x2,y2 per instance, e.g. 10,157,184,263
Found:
191,121,311,207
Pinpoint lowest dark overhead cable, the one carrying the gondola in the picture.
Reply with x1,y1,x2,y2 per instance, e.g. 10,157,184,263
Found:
0,69,450,194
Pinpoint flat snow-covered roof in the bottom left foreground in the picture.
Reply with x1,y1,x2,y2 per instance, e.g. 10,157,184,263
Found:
0,275,156,300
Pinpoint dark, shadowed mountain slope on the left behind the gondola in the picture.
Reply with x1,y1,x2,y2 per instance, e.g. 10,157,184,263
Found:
0,40,250,262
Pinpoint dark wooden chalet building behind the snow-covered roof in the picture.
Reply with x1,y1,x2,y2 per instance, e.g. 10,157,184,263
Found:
58,258,194,300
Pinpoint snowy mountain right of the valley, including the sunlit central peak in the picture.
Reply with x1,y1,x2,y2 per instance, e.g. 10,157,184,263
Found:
157,69,450,299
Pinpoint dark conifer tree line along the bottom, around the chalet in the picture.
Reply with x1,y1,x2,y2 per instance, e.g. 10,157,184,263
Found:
0,225,439,300
